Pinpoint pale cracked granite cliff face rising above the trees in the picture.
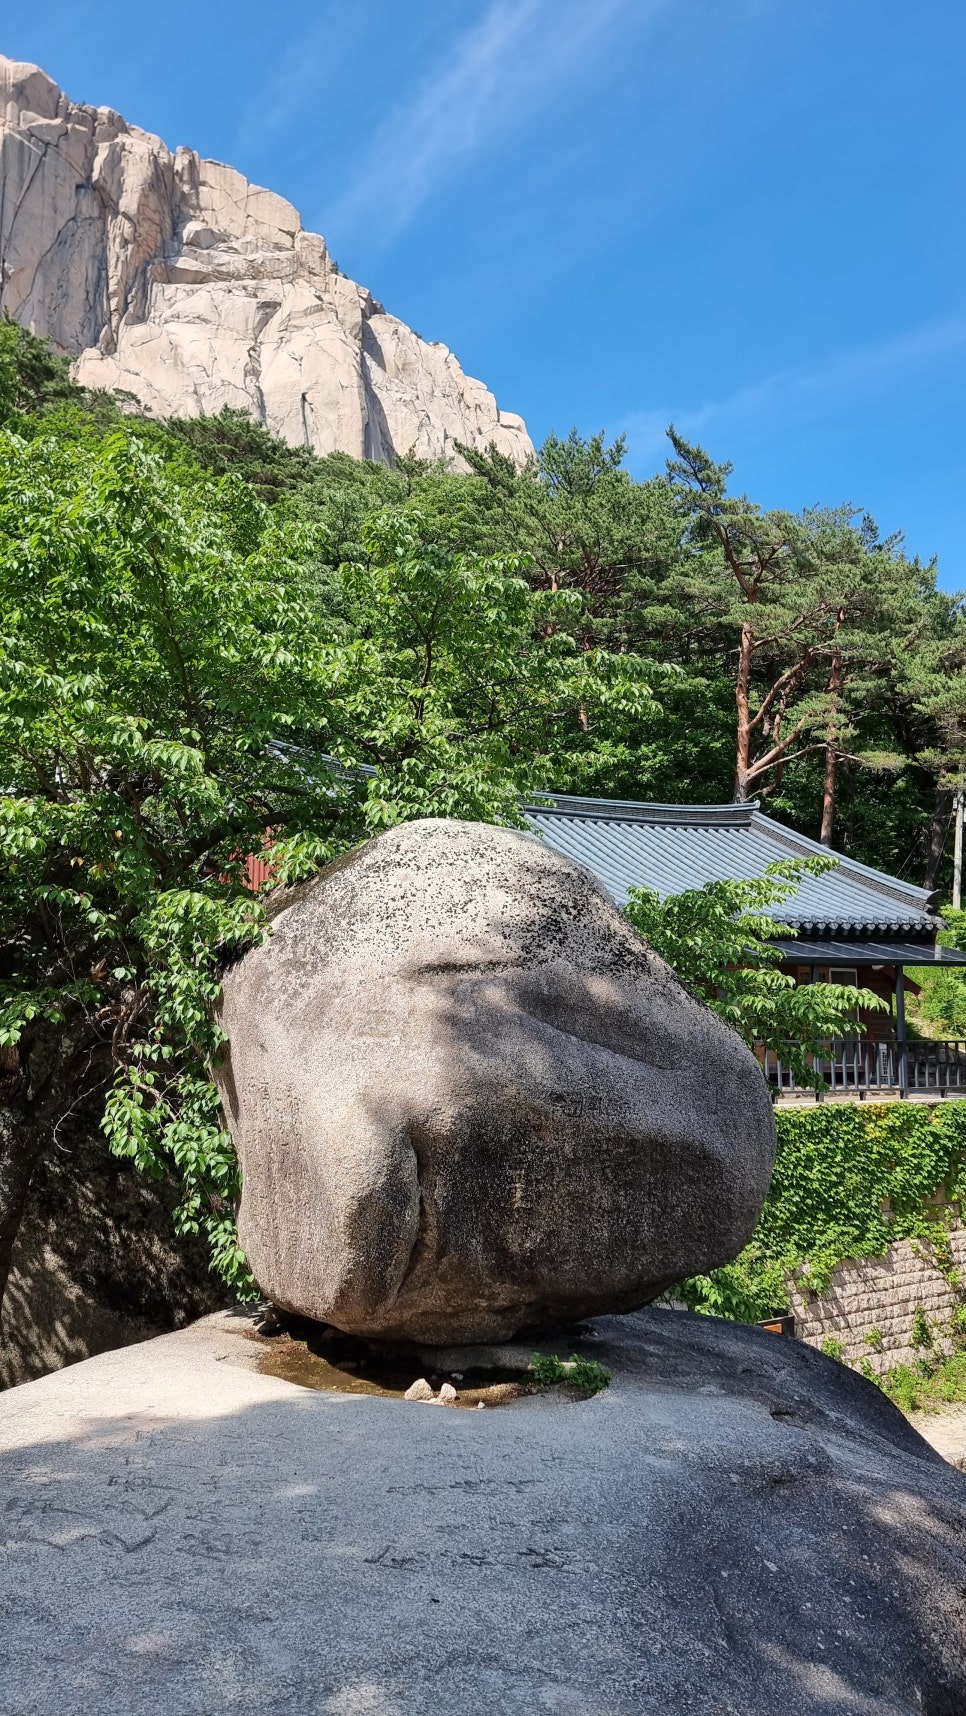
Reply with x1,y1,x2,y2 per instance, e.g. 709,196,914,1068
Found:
0,57,532,462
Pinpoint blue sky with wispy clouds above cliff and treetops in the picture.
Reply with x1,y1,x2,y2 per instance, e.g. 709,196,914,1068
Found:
2,0,966,589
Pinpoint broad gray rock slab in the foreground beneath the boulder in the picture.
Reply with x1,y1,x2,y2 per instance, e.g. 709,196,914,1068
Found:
0,1309,966,1716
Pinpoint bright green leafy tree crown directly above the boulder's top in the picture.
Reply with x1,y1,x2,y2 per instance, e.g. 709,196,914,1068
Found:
326,510,661,827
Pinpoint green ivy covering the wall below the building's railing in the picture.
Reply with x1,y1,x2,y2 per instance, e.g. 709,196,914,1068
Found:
674,1100,966,1323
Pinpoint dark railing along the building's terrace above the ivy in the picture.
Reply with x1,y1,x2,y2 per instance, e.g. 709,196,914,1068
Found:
758,1036,966,1098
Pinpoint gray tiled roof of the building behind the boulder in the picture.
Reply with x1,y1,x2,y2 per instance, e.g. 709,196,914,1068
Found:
527,793,937,942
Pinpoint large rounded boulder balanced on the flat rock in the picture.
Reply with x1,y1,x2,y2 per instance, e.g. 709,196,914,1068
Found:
220,820,774,1344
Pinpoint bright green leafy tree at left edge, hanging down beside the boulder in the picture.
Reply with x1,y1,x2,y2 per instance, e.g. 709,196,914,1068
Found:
0,432,359,1278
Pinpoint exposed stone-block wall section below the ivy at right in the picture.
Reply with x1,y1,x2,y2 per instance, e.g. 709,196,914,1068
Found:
793,1229,966,1371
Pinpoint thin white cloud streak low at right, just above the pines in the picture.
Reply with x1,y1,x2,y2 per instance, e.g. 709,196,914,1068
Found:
621,316,966,465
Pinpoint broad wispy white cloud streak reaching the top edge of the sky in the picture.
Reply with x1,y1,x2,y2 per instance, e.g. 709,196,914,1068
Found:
326,0,671,242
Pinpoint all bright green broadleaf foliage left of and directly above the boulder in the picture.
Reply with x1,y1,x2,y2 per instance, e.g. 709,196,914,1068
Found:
0,417,654,1290
